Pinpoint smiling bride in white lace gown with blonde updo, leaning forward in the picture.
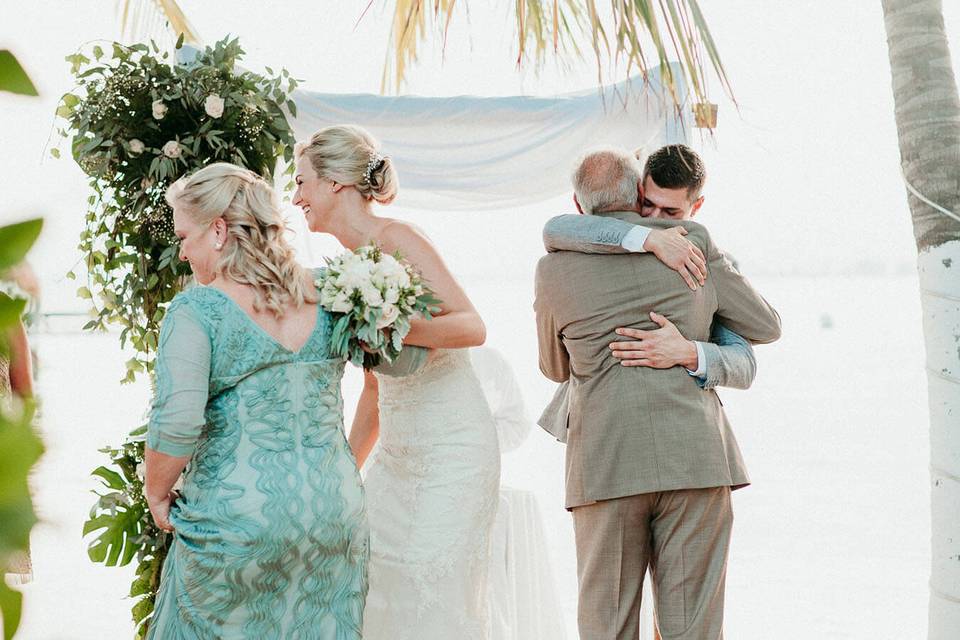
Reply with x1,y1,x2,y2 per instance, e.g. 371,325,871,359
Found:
294,126,500,640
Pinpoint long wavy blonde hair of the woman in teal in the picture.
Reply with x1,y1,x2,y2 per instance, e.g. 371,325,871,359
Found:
166,162,318,318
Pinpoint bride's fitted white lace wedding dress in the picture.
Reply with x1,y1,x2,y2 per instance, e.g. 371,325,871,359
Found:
363,349,500,640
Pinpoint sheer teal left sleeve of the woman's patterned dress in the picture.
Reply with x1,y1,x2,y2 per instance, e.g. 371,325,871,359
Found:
147,300,211,457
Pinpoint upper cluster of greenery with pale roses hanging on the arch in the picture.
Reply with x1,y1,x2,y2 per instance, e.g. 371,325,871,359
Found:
54,39,297,382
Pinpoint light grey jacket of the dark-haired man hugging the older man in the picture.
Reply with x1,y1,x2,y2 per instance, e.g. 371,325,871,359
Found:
537,214,757,442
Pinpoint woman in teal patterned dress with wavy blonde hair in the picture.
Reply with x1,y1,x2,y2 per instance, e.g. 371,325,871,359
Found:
145,163,424,640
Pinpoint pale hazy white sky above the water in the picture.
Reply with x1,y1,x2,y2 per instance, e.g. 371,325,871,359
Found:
0,0,960,306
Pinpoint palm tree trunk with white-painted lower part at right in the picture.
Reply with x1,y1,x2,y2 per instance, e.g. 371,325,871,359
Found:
881,0,960,640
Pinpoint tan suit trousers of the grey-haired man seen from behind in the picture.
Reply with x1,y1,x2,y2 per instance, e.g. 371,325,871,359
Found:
573,487,733,640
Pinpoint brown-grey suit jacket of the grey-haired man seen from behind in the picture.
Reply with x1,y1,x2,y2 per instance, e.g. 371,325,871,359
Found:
534,212,780,507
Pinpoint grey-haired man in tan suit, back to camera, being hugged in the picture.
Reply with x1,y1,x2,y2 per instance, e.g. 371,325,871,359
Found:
534,146,780,640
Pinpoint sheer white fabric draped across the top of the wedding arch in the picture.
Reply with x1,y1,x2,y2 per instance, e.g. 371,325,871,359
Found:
292,68,689,211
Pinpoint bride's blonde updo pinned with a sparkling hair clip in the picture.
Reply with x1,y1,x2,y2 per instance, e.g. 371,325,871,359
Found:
296,124,400,204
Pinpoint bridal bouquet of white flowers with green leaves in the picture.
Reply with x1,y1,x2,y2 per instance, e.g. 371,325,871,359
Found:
316,244,440,369
